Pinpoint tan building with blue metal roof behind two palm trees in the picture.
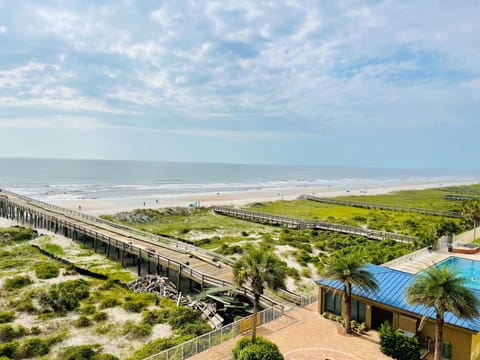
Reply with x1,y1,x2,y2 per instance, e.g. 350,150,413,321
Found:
315,264,480,360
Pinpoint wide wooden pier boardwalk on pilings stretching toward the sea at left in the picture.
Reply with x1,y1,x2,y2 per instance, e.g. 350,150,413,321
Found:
0,190,292,306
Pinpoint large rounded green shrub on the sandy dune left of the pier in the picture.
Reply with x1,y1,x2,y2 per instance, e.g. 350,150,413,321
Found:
39,279,89,313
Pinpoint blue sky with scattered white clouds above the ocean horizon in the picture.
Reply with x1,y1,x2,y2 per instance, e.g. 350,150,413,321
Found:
0,0,480,169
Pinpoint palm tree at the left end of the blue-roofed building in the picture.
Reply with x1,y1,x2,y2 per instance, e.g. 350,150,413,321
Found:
323,254,378,333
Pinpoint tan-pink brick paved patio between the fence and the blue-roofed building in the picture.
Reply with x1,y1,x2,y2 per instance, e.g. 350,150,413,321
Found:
191,303,391,360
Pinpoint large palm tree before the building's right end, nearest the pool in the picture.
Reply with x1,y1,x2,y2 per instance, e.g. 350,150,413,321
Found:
407,266,480,360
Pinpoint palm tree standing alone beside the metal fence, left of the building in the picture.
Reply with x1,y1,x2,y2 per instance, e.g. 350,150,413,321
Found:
233,247,285,344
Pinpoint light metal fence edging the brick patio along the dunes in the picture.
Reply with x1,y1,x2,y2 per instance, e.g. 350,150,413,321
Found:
144,306,284,360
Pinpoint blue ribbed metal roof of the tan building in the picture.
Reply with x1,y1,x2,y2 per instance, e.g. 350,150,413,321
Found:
315,264,480,332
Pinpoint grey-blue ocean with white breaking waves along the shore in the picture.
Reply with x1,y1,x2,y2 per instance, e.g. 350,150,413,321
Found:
0,158,480,201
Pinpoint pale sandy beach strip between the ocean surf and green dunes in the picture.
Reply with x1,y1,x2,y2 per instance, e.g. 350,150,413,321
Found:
49,180,480,215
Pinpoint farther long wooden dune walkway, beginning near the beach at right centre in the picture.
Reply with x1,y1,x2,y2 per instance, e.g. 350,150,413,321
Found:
297,195,463,218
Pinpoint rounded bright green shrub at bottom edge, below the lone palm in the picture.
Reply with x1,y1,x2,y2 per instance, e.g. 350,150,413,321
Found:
232,336,284,360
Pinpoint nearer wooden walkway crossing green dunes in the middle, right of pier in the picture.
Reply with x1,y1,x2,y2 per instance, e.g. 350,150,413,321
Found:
213,206,417,242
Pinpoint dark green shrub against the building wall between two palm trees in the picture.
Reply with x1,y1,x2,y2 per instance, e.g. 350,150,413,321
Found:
380,322,420,360
